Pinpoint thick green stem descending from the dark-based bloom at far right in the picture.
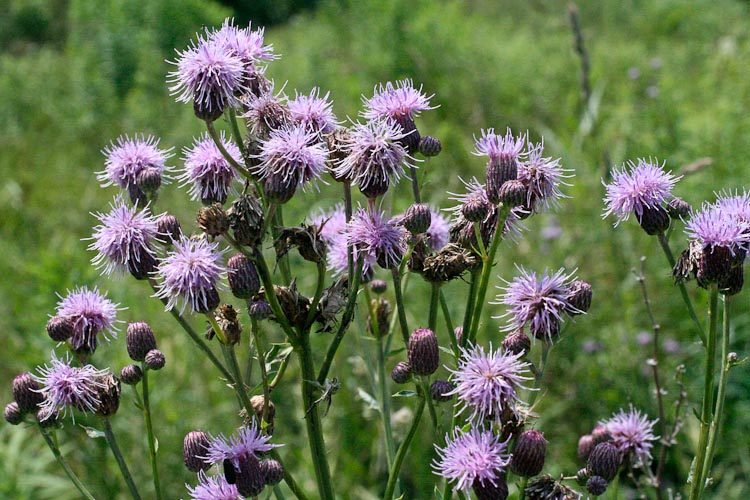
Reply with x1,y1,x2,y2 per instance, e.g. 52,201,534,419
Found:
689,283,719,500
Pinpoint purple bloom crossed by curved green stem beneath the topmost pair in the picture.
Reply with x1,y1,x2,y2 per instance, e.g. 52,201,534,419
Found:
178,133,242,204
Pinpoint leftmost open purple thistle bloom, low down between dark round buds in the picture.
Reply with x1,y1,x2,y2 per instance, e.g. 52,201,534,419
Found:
34,354,109,418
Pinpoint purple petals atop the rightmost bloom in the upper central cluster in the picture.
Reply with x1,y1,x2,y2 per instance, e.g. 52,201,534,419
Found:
362,80,435,123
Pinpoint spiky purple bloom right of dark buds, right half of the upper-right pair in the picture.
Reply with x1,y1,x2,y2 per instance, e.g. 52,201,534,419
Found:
518,141,572,210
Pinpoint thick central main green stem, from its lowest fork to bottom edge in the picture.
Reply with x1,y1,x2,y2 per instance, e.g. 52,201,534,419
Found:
295,331,335,500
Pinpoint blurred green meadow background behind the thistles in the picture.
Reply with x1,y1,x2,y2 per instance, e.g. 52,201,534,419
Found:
0,0,750,499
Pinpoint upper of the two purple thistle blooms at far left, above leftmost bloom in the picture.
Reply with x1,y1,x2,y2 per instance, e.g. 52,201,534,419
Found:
57,286,119,353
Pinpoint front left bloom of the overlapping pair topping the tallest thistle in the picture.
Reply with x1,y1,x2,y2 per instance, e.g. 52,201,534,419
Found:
169,37,244,120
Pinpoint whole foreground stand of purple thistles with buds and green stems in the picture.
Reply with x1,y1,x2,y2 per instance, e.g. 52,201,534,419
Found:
4,15,750,500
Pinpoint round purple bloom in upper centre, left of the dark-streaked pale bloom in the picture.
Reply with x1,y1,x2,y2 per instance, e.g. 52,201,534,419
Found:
254,125,328,187
